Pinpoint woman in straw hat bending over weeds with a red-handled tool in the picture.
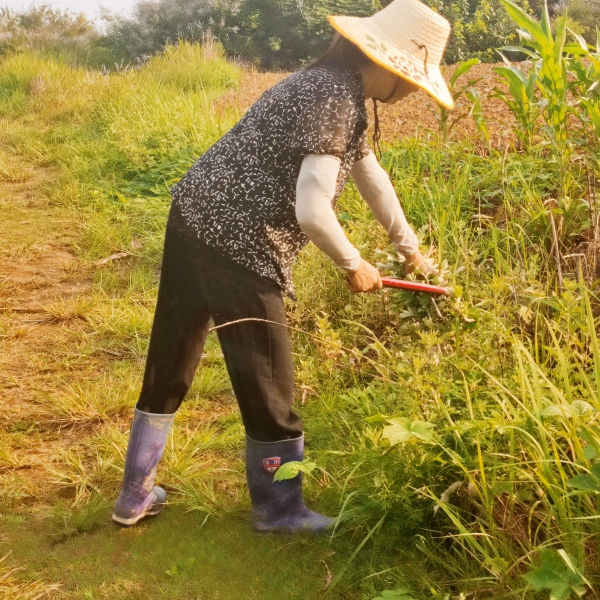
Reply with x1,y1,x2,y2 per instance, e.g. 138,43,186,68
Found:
112,0,453,532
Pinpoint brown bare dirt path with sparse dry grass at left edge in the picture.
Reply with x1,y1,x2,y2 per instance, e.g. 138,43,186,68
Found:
0,169,96,504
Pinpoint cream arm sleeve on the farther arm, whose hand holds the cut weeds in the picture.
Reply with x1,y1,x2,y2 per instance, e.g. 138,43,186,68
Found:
350,153,419,256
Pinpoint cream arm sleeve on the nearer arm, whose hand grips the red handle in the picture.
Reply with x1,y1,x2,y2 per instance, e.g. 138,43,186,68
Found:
296,154,361,271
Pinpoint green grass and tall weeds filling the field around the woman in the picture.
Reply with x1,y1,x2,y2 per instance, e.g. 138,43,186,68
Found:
0,2,600,600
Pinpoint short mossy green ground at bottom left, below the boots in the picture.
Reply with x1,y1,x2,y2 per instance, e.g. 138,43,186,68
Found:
3,506,376,600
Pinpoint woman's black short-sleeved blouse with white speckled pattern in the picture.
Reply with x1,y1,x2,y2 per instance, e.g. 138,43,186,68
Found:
171,67,369,297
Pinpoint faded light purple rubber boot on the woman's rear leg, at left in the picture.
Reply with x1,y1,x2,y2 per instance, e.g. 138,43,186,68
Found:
112,408,175,525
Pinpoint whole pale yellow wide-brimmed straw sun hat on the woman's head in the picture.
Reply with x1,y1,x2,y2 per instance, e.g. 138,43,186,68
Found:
328,0,454,108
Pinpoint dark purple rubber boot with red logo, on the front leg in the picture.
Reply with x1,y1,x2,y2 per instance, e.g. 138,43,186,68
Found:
246,435,334,533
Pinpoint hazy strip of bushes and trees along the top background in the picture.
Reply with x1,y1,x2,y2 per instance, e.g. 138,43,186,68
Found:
0,0,600,69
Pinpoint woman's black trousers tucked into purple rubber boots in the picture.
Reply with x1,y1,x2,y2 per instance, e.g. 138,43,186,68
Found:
137,226,302,442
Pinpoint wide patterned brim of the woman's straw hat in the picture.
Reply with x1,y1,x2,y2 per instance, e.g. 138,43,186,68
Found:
327,15,454,110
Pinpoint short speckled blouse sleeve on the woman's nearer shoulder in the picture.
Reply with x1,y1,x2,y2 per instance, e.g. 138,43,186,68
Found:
295,97,357,160
